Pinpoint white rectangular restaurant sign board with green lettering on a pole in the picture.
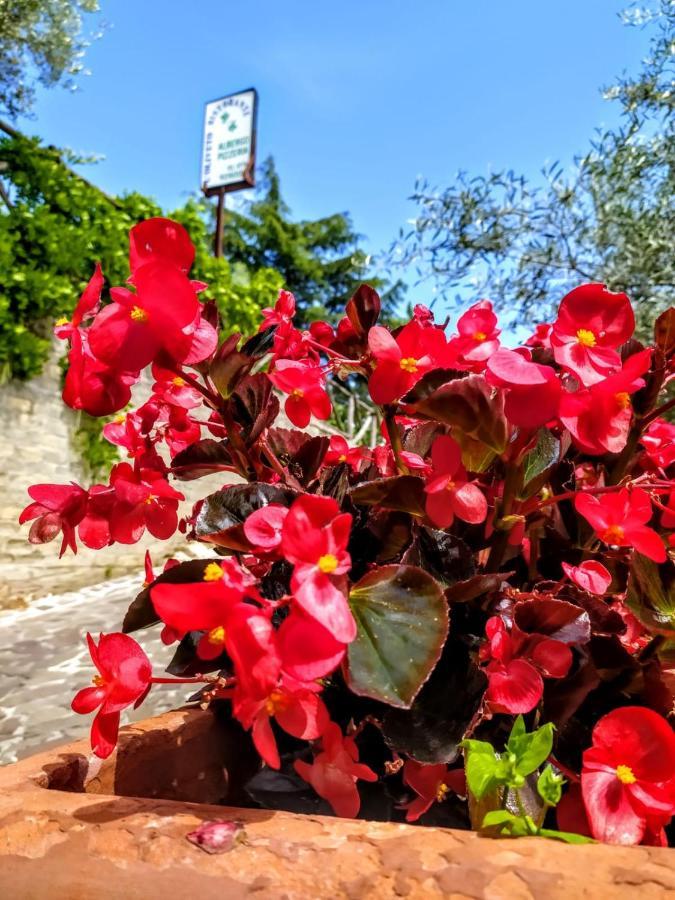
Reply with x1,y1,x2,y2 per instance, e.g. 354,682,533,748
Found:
201,88,258,194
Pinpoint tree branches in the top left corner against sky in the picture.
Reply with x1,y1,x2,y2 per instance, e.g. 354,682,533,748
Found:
0,0,99,118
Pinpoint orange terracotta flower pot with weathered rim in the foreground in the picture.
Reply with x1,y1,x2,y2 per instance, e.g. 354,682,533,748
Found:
0,709,675,900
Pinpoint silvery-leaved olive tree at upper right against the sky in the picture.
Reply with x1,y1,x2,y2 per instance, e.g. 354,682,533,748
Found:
398,0,675,332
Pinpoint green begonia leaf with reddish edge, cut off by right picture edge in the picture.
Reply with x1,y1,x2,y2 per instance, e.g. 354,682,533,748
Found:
626,552,675,638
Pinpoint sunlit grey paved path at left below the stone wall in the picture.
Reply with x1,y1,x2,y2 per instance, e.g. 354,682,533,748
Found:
0,576,190,764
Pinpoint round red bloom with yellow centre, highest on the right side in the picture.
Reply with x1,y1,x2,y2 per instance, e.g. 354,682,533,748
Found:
551,284,635,386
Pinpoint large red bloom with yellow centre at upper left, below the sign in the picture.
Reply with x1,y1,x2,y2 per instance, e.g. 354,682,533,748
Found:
89,261,200,372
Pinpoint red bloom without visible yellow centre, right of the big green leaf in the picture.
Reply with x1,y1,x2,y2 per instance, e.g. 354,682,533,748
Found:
480,616,572,715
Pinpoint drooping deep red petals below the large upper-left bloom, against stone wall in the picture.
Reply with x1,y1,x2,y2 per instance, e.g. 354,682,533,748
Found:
63,329,138,417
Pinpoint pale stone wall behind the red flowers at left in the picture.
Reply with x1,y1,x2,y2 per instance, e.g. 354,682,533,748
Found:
0,350,226,608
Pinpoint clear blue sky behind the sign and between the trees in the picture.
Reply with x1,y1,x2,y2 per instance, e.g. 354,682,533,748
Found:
14,0,646,299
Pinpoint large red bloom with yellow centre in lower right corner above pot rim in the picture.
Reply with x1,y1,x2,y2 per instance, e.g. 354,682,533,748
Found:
581,706,675,844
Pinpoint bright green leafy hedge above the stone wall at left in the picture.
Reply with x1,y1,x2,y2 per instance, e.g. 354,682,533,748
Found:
0,133,282,380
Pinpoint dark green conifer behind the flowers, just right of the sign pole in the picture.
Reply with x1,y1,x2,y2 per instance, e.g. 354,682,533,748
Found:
223,157,402,321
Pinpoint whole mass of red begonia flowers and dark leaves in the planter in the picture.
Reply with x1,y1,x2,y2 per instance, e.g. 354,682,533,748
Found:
21,219,675,843
